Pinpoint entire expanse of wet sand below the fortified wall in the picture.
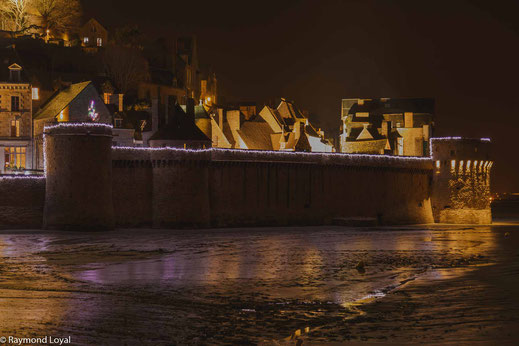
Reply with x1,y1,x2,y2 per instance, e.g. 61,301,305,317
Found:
0,220,519,345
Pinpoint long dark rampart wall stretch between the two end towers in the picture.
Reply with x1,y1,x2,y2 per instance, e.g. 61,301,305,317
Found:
112,148,432,227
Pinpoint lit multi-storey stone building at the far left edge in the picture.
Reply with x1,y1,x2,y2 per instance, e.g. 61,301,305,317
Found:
0,62,34,174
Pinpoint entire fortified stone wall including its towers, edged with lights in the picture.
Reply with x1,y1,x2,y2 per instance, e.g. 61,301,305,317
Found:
0,124,491,230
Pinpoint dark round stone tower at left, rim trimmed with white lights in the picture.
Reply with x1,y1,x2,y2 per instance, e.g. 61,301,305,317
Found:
43,123,115,230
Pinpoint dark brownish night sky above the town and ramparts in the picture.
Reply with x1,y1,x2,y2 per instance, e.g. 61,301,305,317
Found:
83,0,519,192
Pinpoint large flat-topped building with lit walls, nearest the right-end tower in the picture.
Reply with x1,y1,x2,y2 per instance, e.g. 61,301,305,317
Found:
340,98,434,156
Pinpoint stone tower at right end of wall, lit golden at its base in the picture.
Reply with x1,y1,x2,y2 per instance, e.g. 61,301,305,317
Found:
431,137,493,224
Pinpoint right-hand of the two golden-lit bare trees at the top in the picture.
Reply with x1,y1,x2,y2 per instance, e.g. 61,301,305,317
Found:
30,0,81,33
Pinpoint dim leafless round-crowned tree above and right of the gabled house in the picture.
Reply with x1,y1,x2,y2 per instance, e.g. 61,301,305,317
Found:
104,46,149,94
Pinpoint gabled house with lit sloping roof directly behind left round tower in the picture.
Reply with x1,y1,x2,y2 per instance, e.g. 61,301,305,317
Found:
33,81,113,169
